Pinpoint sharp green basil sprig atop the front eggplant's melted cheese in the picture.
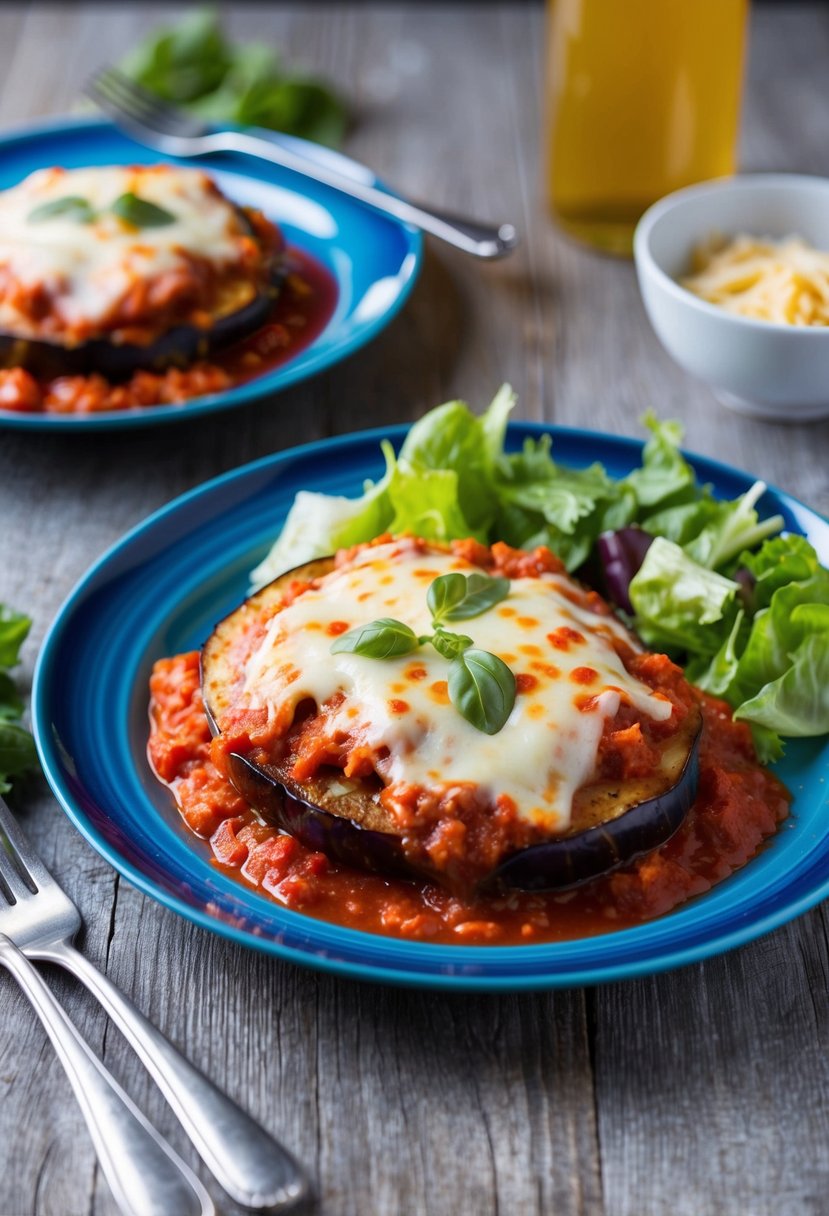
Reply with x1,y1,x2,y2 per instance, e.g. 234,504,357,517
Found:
331,573,515,734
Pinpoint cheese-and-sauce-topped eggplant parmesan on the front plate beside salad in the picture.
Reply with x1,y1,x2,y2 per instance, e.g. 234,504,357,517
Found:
202,537,700,893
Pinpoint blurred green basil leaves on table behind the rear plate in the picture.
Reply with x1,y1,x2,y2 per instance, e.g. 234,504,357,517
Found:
119,7,348,146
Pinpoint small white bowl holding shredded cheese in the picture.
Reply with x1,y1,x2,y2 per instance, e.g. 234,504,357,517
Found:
633,174,829,422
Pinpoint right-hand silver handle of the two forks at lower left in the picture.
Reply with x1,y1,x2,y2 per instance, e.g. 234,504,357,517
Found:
38,942,309,1211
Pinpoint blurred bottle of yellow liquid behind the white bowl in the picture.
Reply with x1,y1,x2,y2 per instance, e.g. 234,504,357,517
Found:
547,0,748,254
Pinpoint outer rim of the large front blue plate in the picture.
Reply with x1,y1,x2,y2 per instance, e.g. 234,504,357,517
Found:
32,422,829,992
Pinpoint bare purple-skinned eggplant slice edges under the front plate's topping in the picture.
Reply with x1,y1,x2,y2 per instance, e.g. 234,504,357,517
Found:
202,558,701,891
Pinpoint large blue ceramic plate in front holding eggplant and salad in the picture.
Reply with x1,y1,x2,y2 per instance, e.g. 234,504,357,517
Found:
33,424,829,991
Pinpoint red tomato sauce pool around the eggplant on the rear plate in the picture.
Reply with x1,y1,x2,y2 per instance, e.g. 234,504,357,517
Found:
0,246,338,413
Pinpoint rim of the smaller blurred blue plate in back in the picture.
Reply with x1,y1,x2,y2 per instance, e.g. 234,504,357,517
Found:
0,114,423,432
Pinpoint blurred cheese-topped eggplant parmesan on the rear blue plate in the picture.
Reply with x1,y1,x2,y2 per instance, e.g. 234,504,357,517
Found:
0,164,282,376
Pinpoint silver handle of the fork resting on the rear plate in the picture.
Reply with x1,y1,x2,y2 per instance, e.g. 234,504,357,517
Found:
198,131,518,258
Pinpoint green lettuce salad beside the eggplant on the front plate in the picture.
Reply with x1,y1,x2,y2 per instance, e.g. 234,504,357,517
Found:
252,385,829,762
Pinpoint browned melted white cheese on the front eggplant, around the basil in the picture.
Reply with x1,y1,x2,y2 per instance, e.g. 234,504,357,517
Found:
243,541,671,831
